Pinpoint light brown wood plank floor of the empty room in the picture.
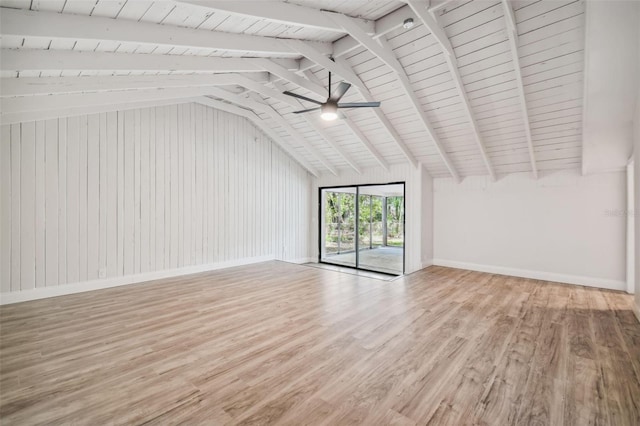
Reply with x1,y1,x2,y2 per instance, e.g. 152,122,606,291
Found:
0,262,640,425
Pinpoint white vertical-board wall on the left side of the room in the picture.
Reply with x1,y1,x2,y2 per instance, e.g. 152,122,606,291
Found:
0,104,311,294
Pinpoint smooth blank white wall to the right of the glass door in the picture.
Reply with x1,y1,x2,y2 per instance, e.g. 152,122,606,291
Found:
434,171,627,290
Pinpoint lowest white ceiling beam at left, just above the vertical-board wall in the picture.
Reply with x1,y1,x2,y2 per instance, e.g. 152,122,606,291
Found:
0,98,192,125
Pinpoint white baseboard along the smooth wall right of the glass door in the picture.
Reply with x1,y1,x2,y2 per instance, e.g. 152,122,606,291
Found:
433,259,627,291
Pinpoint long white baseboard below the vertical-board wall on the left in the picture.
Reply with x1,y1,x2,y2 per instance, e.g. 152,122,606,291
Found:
0,255,275,305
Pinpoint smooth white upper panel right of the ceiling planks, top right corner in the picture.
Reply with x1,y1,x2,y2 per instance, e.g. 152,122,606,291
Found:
582,0,640,173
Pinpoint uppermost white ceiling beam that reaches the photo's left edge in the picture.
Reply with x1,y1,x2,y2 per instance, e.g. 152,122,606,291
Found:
0,9,331,55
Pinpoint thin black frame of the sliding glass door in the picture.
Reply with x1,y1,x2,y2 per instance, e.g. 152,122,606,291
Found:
318,181,407,277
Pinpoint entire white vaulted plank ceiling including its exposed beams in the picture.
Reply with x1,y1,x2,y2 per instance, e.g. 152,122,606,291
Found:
0,0,585,180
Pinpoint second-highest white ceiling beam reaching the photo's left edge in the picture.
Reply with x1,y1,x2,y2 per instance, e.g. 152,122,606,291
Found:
0,49,298,73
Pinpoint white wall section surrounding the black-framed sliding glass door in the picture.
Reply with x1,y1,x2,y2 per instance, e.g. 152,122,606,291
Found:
310,164,432,273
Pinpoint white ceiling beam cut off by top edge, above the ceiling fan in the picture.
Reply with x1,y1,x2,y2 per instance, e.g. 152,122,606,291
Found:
178,0,373,33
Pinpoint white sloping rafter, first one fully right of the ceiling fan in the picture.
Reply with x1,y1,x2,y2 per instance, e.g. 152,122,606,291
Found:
326,12,460,182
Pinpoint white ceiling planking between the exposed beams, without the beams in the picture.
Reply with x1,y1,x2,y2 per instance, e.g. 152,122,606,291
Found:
0,0,600,176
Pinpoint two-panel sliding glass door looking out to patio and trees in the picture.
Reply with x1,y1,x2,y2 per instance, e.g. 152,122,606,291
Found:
320,183,404,275
